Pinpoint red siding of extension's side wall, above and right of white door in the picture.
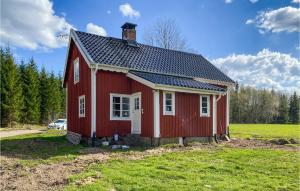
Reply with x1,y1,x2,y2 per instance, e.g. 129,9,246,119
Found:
131,80,154,137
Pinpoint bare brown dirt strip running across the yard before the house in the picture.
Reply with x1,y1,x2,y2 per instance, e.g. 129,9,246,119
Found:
0,139,298,191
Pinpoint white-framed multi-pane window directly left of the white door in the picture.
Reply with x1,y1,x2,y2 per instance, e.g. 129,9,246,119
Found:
110,94,130,120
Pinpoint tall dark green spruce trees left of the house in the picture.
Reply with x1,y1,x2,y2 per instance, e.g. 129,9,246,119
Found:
0,47,65,127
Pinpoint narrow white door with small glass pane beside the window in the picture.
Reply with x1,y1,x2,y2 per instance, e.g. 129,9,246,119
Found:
131,93,141,134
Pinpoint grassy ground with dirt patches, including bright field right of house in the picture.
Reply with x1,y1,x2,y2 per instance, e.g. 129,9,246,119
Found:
0,124,300,191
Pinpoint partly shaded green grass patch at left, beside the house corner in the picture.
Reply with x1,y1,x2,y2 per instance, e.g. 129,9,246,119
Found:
0,130,82,166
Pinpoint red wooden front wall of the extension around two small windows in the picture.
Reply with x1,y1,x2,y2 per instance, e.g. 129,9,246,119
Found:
160,91,213,137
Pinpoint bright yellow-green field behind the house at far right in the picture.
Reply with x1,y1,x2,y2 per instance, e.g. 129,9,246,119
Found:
230,124,300,140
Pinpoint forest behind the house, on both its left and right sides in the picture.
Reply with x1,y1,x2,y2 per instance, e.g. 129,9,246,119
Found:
0,48,300,127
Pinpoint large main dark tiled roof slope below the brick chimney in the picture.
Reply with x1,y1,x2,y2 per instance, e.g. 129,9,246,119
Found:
75,31,234,83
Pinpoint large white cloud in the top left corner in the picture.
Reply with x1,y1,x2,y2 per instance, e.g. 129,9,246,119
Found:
0,0,73,50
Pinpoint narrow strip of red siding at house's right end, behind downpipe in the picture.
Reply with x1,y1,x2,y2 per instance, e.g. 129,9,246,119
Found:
217,95,227,134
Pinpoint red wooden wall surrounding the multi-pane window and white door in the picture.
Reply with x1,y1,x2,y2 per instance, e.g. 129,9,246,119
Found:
96,70,153,137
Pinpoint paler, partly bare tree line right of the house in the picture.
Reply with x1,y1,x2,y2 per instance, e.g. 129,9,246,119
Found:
230,86,300,124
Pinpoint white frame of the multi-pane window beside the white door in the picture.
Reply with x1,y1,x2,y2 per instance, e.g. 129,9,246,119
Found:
109,94,132,121
